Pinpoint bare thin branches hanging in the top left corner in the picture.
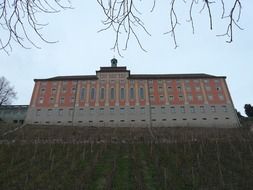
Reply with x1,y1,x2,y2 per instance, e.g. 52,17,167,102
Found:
0,0,70,53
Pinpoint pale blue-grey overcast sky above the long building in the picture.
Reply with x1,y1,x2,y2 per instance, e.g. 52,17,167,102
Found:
0,0,253,113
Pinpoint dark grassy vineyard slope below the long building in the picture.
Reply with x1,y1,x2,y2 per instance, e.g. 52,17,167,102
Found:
0,126,253,190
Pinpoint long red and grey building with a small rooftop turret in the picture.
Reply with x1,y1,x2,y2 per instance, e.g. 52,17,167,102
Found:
26,59,239,127
